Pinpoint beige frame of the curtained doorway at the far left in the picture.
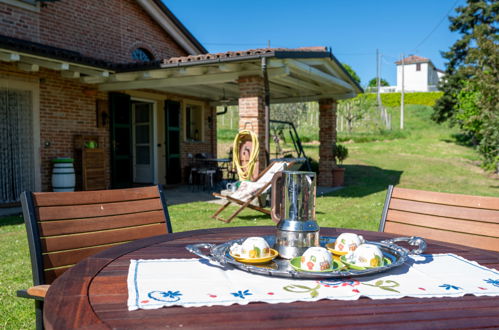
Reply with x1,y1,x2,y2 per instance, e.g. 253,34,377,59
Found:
0,77,42,191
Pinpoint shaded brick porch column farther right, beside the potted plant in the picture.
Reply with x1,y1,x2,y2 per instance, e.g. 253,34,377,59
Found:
317,99,336,186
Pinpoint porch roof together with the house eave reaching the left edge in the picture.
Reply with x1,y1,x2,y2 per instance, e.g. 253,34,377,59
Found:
0,35,363,105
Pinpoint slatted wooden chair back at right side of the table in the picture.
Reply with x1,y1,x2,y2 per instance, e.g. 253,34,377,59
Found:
379,186,499,251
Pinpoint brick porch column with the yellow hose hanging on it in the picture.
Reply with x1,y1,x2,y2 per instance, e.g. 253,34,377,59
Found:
238,76,266,177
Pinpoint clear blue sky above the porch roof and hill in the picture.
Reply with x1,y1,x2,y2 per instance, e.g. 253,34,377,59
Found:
163,0,465,86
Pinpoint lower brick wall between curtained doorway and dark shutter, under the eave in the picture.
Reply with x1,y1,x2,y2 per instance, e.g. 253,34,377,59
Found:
0,63,110,191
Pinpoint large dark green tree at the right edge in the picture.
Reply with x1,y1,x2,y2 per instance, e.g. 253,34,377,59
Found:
432,0,499,171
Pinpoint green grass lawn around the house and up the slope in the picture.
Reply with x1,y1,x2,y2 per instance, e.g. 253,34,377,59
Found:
0,106,499,329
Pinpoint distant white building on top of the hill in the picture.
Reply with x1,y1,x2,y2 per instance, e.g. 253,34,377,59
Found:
395,55,444,92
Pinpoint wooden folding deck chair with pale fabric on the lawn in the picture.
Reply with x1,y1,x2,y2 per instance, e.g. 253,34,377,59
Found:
211,160,302,223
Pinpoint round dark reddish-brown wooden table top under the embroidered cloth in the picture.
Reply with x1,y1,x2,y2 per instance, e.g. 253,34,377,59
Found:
44,227,499,329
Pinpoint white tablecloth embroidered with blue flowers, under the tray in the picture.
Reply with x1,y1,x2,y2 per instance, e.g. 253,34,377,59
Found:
128,254,499,310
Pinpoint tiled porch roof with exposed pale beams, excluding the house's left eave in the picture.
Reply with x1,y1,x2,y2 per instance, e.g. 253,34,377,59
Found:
100,47,363,104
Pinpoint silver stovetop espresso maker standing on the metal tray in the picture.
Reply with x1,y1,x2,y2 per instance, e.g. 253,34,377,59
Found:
271,171,319,259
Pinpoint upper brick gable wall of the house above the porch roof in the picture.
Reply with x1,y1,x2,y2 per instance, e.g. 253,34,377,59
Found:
0,0,187,63
